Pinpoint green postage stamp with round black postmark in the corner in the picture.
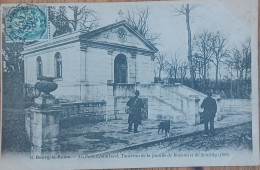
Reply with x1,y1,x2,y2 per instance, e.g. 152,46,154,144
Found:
4,4,48,42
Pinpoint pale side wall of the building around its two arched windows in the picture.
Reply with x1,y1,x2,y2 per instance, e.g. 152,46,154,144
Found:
24,42,80,84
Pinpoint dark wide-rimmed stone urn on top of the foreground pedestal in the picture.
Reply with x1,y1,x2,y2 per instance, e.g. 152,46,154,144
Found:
35,76,58,95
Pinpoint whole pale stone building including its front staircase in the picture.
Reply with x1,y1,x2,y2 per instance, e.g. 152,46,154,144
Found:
23,21,209,124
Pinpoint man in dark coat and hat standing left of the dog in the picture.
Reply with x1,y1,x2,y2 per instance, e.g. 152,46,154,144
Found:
127,90,144,133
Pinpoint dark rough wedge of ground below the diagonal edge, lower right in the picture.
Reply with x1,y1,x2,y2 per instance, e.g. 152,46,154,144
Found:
121,122,252,154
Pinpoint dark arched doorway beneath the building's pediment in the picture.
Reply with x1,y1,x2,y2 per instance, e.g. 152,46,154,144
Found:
114,54,127,83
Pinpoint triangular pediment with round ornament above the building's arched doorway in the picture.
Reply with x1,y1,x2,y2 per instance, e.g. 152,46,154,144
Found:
80,21,158,52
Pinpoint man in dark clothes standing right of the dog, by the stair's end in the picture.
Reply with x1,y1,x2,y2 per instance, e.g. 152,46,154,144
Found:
200,92,217,136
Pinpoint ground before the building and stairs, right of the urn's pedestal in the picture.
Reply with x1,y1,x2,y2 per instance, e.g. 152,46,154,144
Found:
59,99,252,154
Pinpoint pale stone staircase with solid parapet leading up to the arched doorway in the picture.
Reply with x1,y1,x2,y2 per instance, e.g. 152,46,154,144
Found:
114,84,206,125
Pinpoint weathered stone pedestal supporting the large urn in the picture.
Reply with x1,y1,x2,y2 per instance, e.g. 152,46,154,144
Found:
25,96,62,156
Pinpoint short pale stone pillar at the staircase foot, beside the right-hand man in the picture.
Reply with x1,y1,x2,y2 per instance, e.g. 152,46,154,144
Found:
186,95,200,125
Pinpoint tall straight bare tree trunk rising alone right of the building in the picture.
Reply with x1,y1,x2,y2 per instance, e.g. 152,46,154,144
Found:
186,4,195,88
